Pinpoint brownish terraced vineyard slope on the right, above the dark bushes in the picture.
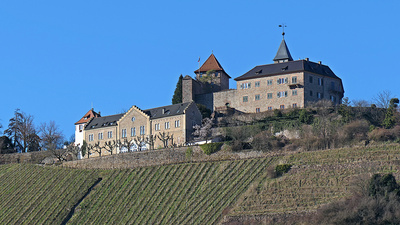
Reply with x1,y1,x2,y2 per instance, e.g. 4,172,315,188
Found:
229,145,400,221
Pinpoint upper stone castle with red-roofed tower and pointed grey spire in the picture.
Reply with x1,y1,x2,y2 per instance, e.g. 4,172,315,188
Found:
182,33,344,113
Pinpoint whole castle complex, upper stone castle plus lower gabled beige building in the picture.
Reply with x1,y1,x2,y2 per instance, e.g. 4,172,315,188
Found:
75,33,344,155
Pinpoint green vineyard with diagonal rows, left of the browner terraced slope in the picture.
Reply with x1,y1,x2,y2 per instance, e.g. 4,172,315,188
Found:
0,159,271,224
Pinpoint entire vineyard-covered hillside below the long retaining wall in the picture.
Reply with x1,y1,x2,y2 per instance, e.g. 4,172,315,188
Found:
0,144,400,224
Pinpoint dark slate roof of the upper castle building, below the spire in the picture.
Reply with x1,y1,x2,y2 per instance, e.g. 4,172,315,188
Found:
235,60,341,81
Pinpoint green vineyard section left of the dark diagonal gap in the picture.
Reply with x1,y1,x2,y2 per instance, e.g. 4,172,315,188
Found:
0,164,97,224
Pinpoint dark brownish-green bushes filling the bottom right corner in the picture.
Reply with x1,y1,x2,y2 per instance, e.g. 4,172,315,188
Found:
309,174,400,224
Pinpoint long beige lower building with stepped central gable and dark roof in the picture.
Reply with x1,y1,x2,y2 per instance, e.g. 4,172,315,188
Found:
80,102,202,157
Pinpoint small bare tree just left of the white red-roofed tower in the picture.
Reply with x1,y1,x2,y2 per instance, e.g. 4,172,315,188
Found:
39,121,64,150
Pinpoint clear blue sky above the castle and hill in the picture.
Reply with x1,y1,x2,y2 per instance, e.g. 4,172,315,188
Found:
0,0,400,138
